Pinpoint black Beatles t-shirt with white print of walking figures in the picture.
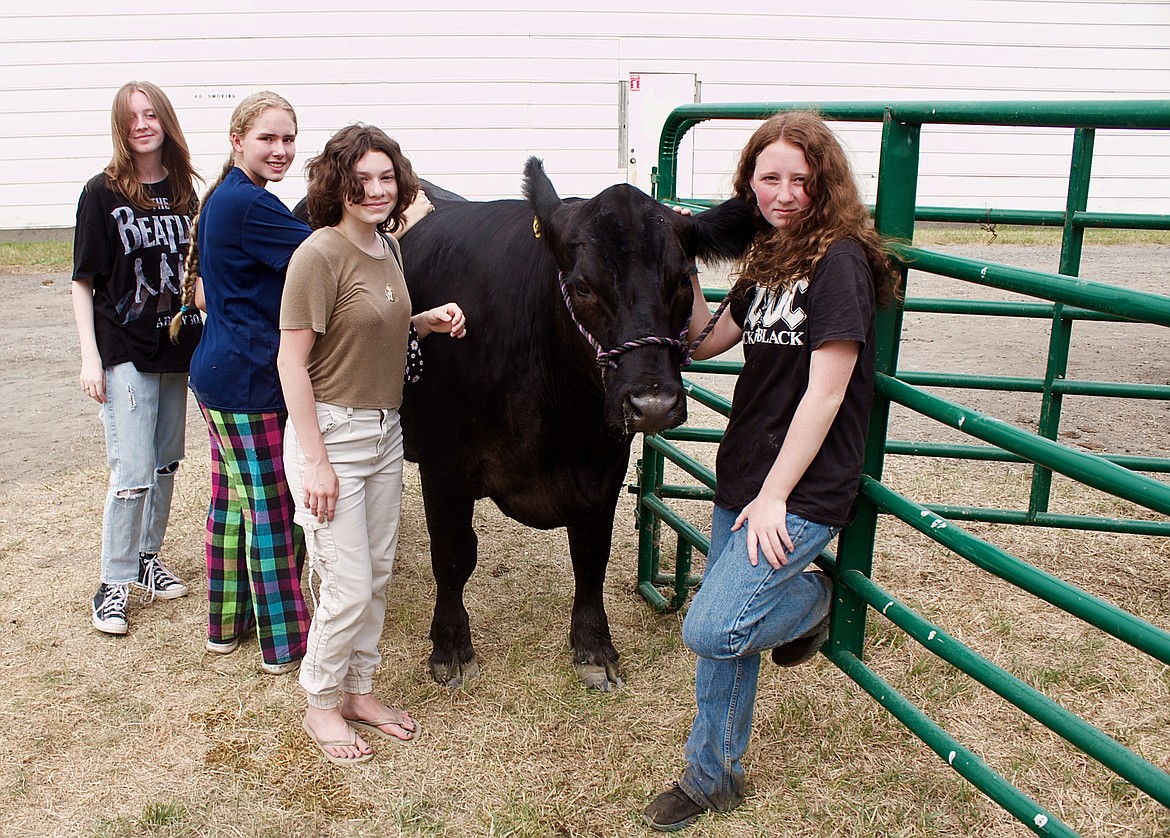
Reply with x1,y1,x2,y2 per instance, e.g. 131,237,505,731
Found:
74,174,202,372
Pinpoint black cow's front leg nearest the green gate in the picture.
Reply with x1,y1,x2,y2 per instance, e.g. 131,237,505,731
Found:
569,497,621,693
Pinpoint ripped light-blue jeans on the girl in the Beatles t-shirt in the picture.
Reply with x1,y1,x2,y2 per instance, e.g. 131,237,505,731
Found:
102,362,187,585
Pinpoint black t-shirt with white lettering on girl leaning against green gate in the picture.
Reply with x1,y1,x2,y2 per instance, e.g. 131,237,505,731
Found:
715,239,875,527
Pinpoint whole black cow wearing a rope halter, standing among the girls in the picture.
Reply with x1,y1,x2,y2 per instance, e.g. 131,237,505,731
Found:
401,157,753,691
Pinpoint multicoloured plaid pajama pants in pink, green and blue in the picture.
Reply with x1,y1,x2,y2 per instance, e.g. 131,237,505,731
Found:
199,405,309,664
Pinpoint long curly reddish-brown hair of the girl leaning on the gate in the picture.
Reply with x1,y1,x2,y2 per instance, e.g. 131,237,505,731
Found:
732,111,901,305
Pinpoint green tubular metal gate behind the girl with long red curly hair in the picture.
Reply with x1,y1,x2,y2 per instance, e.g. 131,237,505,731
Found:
631,101,1170,836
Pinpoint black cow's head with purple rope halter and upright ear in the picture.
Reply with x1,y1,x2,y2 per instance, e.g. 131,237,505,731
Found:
524,157,755,433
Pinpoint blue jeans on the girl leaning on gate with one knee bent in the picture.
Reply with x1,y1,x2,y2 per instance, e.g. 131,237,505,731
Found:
679,506,838,811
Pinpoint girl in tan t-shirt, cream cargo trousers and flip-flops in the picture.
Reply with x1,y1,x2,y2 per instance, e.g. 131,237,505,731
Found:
277,124,467,765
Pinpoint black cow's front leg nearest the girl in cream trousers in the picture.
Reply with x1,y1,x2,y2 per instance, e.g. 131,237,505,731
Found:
421,474,480,688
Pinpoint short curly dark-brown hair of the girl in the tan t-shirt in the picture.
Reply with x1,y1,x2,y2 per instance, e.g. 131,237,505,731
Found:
304,123,419,233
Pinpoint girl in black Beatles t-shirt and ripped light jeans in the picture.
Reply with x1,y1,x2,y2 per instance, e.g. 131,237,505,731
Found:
73,82,201,634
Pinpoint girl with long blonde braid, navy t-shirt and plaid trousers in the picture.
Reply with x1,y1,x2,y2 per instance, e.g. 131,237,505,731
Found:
176,91,309,675
